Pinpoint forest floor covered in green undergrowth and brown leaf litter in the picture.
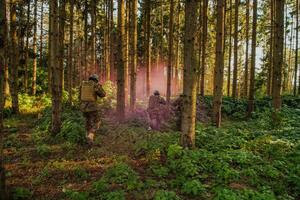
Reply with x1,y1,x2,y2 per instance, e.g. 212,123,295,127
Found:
4,95,300,200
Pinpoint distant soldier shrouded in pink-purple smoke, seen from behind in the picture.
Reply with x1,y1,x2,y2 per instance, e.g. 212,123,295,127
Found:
147,90,166,130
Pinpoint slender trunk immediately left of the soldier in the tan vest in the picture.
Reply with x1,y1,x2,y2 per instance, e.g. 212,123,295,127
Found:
68,0,74,104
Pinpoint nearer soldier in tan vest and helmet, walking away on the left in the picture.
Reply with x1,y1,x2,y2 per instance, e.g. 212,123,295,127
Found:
80,74,106,143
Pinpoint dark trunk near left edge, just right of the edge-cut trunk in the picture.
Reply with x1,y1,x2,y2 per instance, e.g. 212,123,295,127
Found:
10,0,19,114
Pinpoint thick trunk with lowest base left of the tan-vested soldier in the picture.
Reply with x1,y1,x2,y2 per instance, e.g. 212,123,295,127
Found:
49,0,62,135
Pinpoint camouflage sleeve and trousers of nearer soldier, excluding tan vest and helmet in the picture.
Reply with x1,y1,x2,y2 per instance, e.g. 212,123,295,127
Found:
80,80,106,141
